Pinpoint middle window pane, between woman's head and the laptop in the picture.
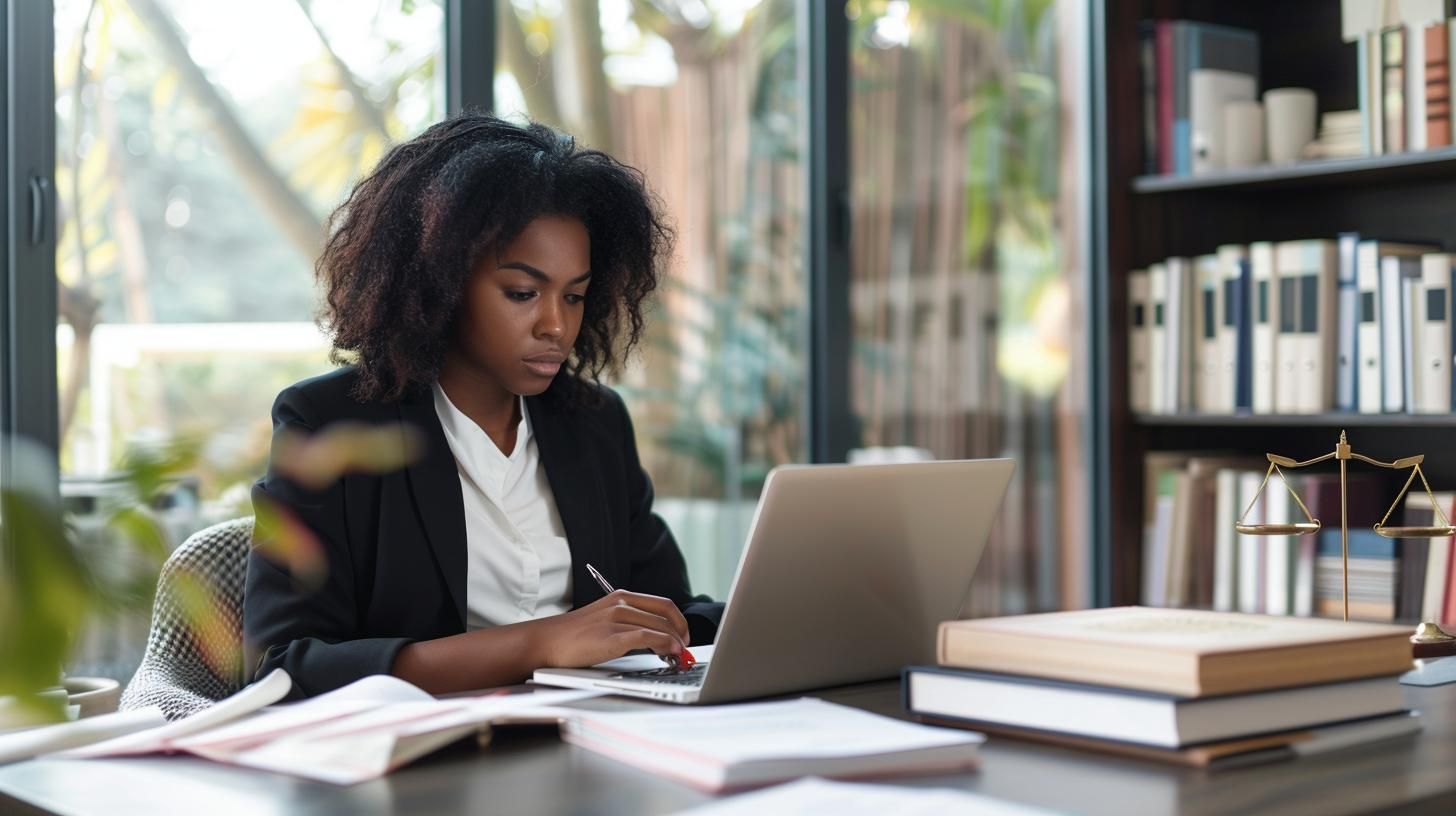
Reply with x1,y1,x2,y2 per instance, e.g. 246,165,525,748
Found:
495,0,807,597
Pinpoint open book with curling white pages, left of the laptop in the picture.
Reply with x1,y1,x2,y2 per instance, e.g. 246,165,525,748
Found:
57,670,600,784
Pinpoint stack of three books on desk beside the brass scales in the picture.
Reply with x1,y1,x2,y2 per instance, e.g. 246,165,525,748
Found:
903,606,1420,766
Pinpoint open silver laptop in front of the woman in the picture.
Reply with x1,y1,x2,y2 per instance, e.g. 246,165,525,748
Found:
531,459,1015,704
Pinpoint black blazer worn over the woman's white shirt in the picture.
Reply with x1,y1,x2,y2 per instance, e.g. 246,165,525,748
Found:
243,367,722,697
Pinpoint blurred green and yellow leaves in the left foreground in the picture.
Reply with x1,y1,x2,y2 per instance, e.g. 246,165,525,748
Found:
0,425,421,721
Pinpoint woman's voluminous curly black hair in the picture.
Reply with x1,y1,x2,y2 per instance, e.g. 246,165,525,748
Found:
316,112,674,401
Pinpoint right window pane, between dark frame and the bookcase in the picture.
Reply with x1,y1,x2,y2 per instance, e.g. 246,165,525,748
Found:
846,0,1092,613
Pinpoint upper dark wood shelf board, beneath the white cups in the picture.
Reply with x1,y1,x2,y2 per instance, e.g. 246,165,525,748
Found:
1133,147,1456,194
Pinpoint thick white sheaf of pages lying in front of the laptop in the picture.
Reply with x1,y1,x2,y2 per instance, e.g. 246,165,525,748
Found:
562,698,984,793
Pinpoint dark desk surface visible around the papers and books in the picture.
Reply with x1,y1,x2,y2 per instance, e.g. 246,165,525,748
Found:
0,683,1456,816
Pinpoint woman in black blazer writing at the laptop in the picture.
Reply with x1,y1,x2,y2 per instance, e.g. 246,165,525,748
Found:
243,114,722,695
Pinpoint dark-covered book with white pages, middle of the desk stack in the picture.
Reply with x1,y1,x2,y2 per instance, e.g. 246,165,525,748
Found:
901,666,1405,748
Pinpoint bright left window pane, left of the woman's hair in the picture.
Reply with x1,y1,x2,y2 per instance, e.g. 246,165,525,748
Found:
55,0,444,679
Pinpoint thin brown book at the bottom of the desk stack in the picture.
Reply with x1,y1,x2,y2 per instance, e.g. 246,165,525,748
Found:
916,711,1421,771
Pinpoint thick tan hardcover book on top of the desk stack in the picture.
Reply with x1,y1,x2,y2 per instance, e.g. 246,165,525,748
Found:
936,606,1411,697
